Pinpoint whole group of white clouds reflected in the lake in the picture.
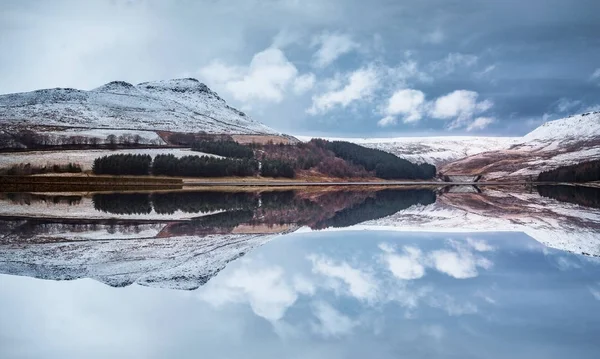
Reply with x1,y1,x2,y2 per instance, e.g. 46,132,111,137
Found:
199,239,494,338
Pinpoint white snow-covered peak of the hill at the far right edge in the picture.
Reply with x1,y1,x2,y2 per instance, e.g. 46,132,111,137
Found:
522,112,600,142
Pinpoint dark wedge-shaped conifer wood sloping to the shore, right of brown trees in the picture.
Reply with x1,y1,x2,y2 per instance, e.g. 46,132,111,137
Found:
316,140,436,179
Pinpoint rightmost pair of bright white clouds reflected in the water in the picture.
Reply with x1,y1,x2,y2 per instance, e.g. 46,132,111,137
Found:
379,238,494,280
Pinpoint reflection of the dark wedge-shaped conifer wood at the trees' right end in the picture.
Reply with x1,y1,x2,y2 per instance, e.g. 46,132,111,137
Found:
316,189,436,228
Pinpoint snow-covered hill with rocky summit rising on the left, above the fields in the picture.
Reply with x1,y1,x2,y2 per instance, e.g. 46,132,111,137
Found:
0,78,277,134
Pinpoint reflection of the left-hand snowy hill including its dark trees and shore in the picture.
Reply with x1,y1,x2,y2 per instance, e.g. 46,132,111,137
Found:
0,190,435,289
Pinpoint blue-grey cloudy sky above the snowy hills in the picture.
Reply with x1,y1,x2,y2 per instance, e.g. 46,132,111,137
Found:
0,0,600,137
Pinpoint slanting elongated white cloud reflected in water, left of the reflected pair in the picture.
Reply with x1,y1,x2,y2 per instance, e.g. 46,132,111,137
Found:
308,255,377,300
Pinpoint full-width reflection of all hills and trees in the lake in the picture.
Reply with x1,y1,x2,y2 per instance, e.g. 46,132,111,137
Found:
0,189,600,289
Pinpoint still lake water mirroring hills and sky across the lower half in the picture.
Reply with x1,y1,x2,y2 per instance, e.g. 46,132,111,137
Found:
0,187,600,358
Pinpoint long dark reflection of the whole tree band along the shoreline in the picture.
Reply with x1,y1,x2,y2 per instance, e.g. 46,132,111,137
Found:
93,189,436,229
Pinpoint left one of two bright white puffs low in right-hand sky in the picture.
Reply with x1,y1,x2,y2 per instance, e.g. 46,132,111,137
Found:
377,89,425,127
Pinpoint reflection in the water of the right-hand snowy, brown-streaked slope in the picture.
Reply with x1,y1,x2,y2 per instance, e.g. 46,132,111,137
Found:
349,191,600,256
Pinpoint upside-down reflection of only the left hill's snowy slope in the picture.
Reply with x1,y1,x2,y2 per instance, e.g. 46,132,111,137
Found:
0,235,273,290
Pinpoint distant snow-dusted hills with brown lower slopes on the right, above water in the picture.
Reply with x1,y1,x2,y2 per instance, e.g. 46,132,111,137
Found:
338,112,600,179
